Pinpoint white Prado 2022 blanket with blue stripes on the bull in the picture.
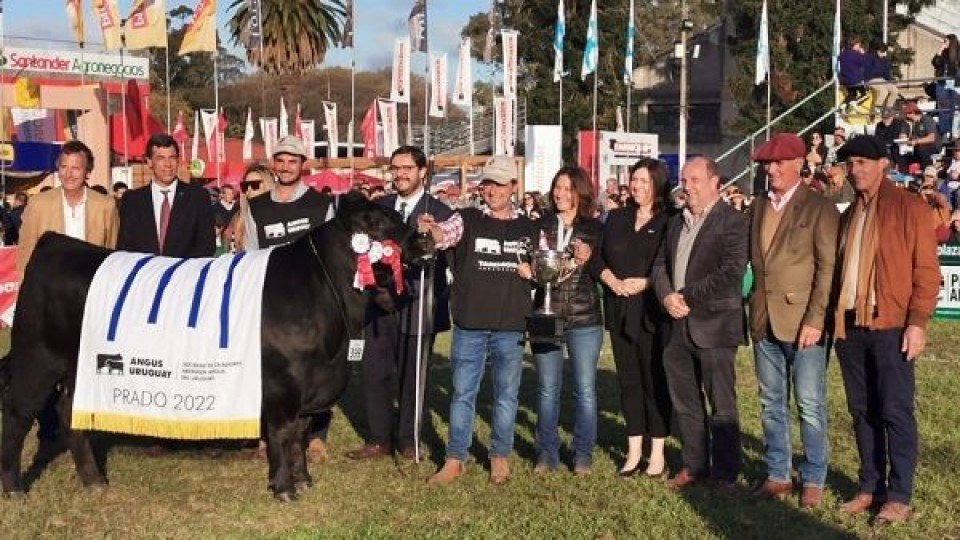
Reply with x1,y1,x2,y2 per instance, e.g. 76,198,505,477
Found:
72,249,272,439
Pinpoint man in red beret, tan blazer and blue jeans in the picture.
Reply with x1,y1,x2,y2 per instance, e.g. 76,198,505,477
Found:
750,133,840,508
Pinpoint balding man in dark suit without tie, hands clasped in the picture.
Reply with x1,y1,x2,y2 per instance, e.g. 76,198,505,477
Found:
652,157,750,489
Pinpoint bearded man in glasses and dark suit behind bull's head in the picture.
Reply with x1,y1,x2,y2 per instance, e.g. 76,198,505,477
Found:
347,146,453,459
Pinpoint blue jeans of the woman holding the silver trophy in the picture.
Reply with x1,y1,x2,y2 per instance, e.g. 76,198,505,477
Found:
532,325,603,468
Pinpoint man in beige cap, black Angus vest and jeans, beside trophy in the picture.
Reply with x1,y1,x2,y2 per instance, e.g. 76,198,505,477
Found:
418,156,538,484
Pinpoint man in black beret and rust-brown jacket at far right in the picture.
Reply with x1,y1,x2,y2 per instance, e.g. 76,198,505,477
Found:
834,135,941,524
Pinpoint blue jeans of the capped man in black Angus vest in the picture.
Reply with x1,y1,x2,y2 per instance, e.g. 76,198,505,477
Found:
447,326,523,461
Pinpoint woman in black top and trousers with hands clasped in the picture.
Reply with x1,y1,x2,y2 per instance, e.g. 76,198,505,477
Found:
592,159,671,477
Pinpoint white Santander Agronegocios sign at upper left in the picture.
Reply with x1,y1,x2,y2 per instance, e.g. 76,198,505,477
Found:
0,47,150,80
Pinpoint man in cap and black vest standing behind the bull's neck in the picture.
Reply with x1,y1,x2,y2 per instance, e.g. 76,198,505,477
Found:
244,136,334,460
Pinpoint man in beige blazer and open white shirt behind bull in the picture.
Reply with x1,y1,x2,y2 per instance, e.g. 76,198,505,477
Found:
14,141,120,461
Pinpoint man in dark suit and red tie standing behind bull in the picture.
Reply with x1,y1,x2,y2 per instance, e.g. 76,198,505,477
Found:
117,133,216,257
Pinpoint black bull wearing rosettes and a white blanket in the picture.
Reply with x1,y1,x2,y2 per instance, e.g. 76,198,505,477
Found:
0,197,432,500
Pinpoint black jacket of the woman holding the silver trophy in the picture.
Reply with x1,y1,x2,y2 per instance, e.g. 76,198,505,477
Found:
533,213,603,328
